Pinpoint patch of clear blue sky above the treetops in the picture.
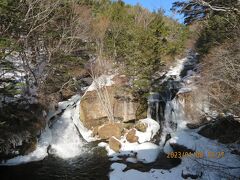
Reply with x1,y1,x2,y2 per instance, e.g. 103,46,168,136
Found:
123,0,183,22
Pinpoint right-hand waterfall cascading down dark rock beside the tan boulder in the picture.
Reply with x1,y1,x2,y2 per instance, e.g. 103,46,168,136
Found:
152,52,197,146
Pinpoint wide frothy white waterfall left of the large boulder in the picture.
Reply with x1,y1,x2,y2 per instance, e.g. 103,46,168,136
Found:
2,95,93,165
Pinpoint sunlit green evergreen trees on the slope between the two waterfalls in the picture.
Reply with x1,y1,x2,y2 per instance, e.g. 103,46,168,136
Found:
93,1,187,92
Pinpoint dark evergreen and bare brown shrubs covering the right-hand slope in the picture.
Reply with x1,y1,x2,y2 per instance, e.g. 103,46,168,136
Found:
172,0,240,116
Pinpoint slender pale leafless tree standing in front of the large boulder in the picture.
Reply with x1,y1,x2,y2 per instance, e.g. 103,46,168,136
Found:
89,16,114,122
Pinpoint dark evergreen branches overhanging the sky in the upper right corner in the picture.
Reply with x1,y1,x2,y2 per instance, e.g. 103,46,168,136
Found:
172,0,240,55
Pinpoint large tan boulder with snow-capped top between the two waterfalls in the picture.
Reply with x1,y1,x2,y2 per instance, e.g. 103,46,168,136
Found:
80,76,139,129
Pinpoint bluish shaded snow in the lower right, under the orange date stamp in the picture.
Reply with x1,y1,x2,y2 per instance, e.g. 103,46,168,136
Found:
109,126,240,180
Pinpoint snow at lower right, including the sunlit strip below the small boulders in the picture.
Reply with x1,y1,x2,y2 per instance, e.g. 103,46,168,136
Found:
107,107,240,180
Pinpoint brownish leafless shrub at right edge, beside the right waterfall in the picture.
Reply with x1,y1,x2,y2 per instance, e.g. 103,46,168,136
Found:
201,41,240,115
